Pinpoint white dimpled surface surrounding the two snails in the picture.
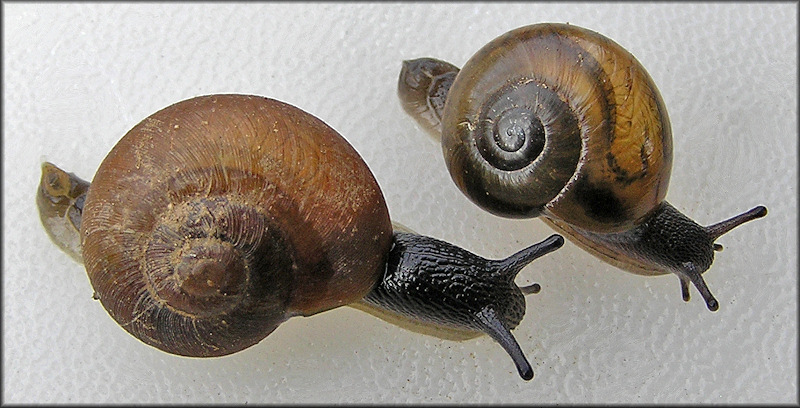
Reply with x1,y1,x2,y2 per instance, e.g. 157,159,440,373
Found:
2,2,798,403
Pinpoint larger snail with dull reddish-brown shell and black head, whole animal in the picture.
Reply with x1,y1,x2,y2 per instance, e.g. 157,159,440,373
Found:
37,94,564,380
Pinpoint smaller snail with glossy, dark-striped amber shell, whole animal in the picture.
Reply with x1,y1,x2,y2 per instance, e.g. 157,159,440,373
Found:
398,24,767,311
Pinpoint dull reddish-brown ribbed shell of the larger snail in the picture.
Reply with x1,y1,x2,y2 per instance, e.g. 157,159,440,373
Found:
80,95,392,356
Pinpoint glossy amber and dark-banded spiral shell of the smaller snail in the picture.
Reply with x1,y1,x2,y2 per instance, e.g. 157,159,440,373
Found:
442,24,672,232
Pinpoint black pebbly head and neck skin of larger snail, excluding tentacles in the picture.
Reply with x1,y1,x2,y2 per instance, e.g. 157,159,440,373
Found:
364,233,525,331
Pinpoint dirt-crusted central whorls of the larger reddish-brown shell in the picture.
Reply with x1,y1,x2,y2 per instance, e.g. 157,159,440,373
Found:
144,196,294,317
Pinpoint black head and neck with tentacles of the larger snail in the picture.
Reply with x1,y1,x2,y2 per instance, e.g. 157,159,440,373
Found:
364,232,564,380
